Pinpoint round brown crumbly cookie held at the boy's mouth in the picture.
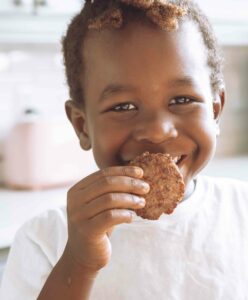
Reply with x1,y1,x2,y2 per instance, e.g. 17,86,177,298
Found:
129,152,185,220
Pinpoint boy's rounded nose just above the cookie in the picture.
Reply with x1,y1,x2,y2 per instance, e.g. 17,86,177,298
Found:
133,113,178,144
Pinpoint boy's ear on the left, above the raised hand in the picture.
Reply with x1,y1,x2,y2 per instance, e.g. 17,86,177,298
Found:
65,100,91,150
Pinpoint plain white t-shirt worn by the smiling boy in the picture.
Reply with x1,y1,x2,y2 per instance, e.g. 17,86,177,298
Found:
0,176,248,300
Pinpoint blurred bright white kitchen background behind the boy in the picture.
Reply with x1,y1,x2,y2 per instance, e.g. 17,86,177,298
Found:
0,0,248,280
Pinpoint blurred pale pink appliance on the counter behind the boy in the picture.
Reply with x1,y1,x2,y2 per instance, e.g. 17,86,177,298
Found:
4,109,96,189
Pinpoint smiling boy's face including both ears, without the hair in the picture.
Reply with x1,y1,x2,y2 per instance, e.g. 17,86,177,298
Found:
67,22,224,195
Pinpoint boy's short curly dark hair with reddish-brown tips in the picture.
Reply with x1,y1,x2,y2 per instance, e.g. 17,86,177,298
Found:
62,0,224,104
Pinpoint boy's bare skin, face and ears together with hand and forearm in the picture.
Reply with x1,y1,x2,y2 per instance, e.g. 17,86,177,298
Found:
38,22,225,300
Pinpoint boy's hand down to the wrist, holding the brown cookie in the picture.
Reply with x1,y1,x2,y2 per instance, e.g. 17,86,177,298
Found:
67,166,149,271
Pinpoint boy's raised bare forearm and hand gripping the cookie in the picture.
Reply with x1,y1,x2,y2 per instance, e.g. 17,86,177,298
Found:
38,167,149,300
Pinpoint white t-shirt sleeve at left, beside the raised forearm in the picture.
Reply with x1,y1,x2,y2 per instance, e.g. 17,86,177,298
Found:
0,209,67,300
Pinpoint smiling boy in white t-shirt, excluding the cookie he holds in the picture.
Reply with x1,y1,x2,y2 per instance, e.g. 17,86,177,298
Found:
1,0,248,300
